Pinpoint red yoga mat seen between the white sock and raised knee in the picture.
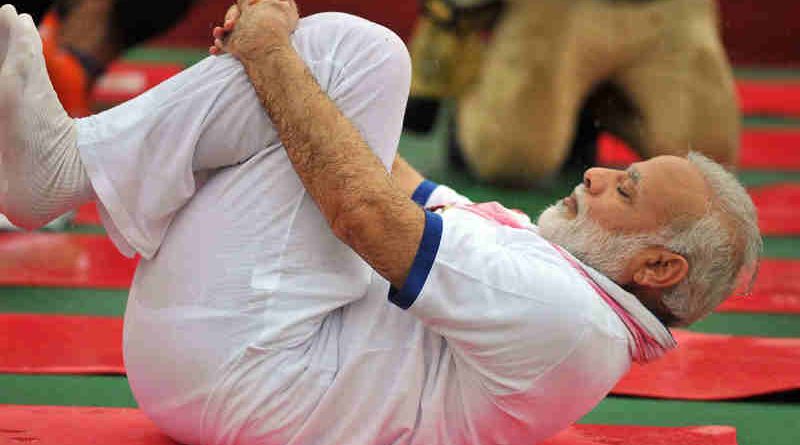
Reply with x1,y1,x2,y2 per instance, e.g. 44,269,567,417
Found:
91,61,184,105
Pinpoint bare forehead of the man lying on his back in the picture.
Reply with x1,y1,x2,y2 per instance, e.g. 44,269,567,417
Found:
629,156,710,221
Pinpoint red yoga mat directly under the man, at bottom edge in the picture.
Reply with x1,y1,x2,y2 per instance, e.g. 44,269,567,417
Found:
0,405,736,445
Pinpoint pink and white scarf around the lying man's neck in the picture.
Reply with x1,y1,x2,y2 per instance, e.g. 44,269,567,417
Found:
455,202,666,363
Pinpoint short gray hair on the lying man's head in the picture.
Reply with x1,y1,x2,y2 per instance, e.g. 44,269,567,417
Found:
662,152,763,326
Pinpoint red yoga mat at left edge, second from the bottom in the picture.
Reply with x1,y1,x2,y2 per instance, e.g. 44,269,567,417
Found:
0,314,125,374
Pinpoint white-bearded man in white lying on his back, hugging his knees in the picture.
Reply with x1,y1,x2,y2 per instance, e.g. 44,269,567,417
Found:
0,0,760,445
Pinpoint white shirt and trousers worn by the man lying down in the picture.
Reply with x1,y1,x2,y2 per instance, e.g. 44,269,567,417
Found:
78,10,664,445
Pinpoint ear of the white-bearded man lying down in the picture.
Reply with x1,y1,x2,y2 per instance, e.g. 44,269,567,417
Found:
633,247,689,289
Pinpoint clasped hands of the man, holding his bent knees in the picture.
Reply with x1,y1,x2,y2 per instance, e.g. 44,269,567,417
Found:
208,0,299,60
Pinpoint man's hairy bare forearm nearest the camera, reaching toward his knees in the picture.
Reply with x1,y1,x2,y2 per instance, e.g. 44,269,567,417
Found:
241,45,424,286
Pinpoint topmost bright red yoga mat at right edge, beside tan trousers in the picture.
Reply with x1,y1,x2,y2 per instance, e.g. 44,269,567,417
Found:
736,79,800,116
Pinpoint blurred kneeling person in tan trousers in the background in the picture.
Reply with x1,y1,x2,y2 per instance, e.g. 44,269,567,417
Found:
406,0,740,185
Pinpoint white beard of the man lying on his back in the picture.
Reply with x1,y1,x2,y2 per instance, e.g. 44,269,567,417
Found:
537,186,658,281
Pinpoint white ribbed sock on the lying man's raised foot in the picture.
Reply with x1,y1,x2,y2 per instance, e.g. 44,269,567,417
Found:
0,5,94,229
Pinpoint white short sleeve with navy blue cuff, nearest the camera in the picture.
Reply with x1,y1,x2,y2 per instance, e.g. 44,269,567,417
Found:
389,209,585,394
